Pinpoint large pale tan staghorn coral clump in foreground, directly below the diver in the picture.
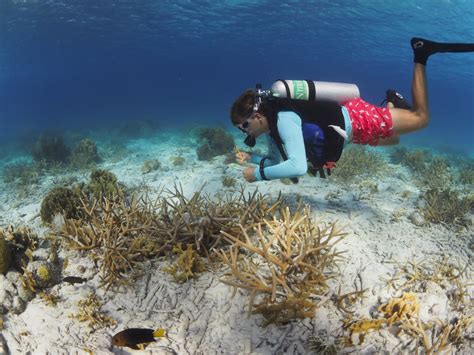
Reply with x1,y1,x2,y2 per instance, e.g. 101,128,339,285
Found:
218,207,345,325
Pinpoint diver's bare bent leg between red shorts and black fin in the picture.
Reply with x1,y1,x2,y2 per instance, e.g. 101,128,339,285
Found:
389,63,429,136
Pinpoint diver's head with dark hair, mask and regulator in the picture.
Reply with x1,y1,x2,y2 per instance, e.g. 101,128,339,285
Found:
230,89,269,146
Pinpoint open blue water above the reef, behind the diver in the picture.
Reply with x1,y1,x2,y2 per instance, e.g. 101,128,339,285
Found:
0,0,474,154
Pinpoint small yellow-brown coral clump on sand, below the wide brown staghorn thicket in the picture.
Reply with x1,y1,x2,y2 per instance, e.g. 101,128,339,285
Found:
163,243,205,282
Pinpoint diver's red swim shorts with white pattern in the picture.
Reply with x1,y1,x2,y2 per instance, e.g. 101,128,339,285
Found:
343,98,393,145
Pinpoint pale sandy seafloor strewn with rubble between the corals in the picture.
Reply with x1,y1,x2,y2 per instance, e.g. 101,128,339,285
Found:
0,132,474,354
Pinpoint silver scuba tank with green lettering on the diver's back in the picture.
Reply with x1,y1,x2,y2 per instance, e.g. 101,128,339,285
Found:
270,80,360,104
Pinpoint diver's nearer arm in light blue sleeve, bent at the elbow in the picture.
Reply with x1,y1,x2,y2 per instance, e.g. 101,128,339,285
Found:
255,112,308,181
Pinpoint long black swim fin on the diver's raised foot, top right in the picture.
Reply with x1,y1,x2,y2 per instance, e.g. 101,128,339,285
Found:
410,37,474,65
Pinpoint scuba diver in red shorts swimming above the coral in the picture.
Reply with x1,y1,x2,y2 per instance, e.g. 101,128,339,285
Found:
230,38,474,183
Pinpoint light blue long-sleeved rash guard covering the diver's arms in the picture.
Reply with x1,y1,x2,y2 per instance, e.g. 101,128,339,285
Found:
250,111,308,181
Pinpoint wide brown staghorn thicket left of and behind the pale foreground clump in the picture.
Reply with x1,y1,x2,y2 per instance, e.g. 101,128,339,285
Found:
60,186,282,288
